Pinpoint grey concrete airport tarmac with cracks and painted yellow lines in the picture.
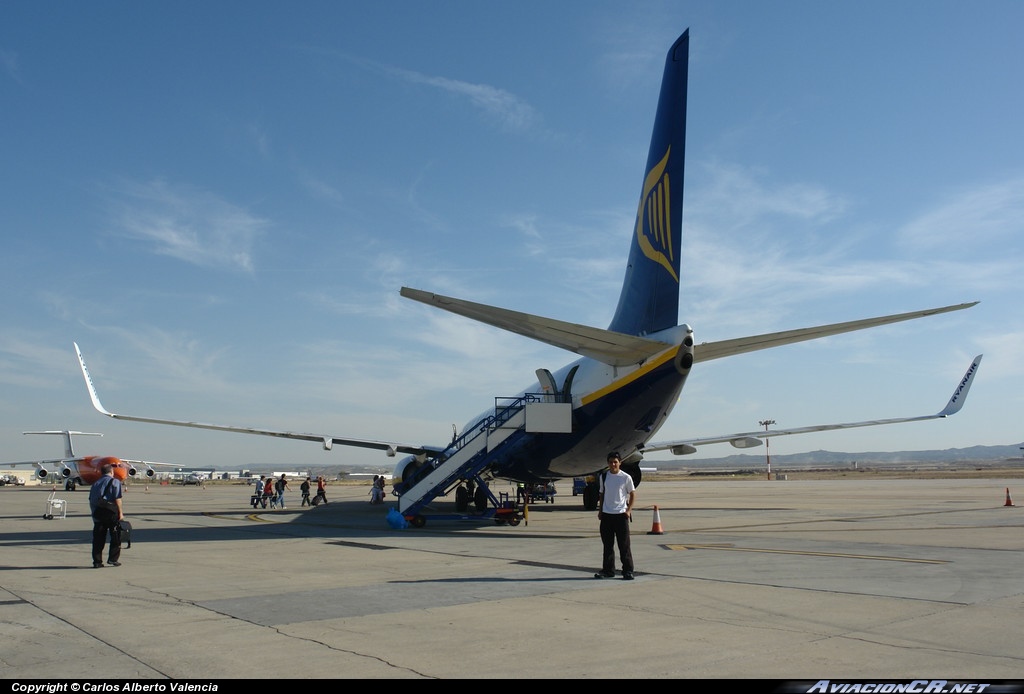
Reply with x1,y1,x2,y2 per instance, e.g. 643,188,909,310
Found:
0,475,1024,682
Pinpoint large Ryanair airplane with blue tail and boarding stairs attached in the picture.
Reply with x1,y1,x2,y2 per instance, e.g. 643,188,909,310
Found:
75,32,981,518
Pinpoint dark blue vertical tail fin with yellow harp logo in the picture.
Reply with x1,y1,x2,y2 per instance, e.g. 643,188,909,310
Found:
608,30,690,335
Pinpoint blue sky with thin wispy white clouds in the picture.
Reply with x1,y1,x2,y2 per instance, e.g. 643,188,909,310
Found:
0,1,1024,469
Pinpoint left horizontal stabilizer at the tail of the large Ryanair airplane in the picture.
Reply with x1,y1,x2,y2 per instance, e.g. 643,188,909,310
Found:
400,287,673,366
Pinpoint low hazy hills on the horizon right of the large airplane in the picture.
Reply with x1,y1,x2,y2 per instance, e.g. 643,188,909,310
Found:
643,442,1024,470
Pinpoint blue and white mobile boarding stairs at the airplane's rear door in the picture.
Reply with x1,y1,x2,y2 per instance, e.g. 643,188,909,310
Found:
398,393,572,518
